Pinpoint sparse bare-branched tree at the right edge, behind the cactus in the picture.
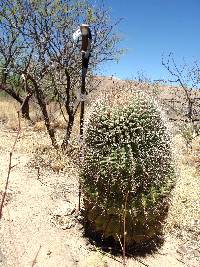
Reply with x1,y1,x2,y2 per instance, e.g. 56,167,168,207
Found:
162,53,200,129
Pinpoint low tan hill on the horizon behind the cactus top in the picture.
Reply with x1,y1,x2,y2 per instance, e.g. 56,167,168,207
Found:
87,76,200,123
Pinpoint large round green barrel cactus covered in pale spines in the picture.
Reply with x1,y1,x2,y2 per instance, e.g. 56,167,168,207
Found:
82,91,174,244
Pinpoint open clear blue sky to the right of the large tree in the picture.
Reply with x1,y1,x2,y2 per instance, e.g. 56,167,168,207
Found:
103,0,200,79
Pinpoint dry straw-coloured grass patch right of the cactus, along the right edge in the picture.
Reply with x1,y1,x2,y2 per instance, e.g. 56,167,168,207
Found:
166,136,200,234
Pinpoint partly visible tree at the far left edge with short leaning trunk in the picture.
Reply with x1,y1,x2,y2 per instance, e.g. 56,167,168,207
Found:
0,9,32,120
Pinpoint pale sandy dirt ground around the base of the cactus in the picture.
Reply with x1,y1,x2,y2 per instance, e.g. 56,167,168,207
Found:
0,125,200,267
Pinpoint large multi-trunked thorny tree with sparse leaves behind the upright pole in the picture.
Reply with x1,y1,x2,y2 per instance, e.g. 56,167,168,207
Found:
0,0,121,147
